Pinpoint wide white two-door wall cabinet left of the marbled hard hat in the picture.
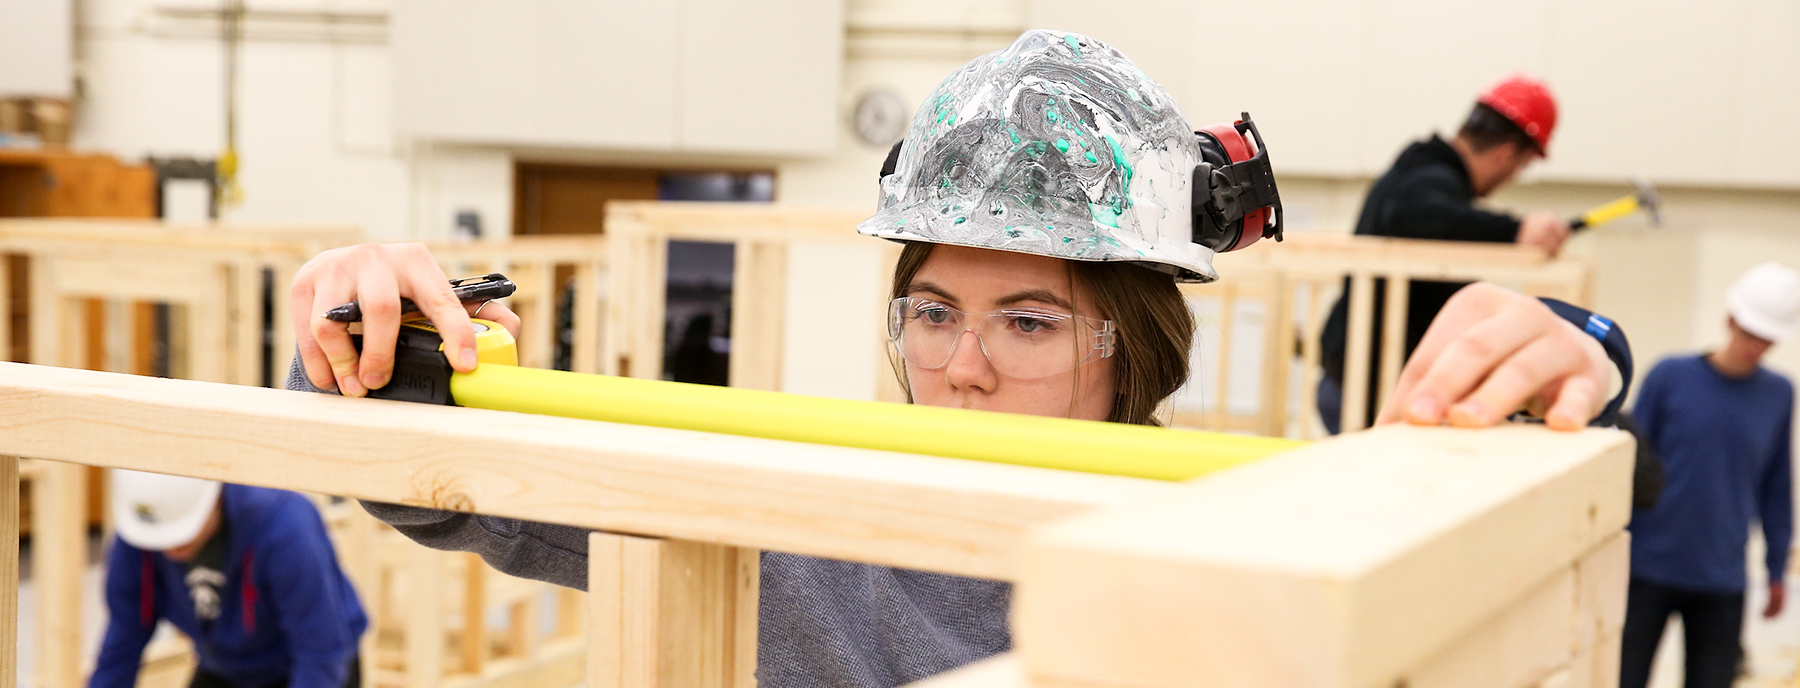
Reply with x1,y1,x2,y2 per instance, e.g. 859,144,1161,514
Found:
391,0,844,155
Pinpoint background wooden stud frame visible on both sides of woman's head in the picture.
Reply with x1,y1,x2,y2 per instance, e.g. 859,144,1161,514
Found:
599,202,1593,438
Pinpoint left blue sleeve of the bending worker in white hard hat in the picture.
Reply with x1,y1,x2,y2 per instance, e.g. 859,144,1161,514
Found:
88,537,158,688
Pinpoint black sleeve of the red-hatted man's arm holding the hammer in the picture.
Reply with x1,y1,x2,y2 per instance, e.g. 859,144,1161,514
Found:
1384,166,1519,243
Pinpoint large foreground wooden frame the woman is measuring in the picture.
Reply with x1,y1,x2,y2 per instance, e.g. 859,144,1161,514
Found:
0,364,1633,688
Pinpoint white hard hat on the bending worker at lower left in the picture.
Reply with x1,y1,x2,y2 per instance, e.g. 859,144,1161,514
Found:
112,468,221,551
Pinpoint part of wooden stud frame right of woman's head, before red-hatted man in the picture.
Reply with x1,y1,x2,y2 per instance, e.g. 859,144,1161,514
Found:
1174,234,1593,438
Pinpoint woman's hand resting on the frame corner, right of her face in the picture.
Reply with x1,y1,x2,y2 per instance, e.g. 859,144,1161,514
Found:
1375,283,1613,430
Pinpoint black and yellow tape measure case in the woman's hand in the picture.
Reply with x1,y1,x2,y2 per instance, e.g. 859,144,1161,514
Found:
351,319,518,405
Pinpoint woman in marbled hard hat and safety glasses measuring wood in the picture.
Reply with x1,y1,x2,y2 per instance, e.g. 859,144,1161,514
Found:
290,31,1634,688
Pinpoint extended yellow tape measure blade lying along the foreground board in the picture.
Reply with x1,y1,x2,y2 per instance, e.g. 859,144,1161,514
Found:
450,366,1301,481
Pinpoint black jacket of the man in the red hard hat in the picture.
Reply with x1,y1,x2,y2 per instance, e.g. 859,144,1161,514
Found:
1319,135,1519,420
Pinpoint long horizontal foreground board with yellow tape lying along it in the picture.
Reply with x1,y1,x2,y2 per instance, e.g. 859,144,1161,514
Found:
0,364,1181,578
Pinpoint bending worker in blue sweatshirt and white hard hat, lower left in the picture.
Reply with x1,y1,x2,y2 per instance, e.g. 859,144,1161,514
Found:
88,470,369,688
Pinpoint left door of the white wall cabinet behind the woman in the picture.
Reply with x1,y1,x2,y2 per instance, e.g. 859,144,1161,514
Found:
391,0,680,149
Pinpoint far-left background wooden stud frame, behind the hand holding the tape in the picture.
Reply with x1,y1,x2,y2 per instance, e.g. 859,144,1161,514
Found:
0,220,607,384
